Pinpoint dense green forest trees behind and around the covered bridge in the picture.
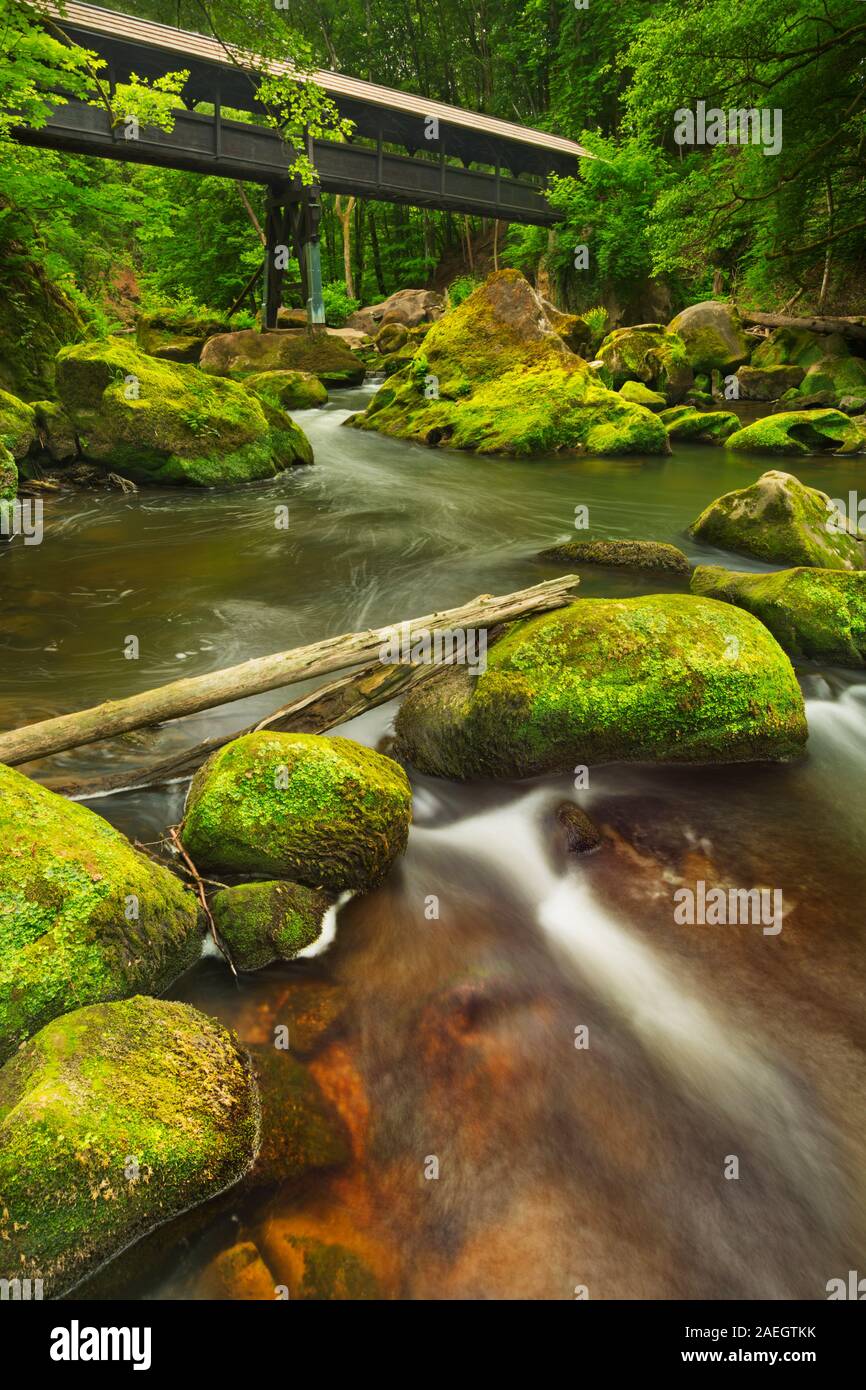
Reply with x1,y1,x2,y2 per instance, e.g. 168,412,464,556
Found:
0,0,866,346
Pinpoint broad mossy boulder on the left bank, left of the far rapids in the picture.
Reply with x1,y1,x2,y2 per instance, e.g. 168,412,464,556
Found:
57,338,313,488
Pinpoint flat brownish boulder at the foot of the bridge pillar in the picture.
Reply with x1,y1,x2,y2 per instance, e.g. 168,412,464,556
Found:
200,328,366,386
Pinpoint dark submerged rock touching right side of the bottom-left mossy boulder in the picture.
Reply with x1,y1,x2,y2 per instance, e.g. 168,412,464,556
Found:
246,1038,349,1187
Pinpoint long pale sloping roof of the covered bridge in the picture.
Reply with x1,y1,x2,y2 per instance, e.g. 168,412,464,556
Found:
46,0,594,174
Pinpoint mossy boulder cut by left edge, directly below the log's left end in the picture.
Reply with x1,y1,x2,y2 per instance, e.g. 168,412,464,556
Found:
0,765,202,1061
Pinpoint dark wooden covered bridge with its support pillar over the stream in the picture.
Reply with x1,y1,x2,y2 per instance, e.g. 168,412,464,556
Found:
17,0,592,327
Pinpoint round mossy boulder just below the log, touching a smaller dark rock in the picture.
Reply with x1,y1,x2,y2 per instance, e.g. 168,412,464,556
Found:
182,733,411,891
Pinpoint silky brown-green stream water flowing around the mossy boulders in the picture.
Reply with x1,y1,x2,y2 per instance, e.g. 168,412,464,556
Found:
0,391,866,1298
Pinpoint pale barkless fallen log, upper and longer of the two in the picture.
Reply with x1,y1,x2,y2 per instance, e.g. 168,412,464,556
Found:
0,574,580,766
